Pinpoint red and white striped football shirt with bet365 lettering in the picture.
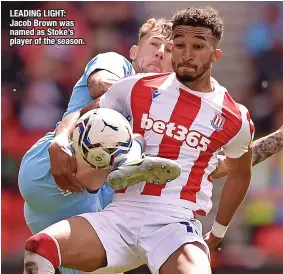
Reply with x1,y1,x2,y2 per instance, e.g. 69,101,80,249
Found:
100,73,254,215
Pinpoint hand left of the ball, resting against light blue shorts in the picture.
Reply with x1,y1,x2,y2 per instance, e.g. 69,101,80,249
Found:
49,142,83,193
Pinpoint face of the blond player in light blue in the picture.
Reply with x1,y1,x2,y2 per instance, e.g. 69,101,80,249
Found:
130,31,173,73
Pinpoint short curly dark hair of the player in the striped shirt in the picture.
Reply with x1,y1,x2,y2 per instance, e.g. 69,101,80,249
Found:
171,7,224,40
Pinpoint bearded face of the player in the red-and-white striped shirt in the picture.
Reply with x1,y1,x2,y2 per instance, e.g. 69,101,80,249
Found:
172,26,221,82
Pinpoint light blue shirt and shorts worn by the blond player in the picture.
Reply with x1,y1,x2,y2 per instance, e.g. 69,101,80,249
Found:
19,52,133,233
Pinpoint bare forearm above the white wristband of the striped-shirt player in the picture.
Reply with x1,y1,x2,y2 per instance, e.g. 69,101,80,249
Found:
216,170,251,226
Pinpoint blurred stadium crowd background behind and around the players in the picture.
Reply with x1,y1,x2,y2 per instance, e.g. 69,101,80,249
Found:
1,1,283,274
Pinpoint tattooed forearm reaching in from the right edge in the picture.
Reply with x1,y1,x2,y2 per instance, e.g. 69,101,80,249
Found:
252,130,283,165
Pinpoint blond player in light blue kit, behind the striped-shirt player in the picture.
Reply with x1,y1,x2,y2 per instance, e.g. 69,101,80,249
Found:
18,19,176,274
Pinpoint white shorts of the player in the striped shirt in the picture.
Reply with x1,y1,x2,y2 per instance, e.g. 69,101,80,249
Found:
79,200,209,274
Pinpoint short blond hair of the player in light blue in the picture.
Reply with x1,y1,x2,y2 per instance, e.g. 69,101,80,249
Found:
139,18,172,41
